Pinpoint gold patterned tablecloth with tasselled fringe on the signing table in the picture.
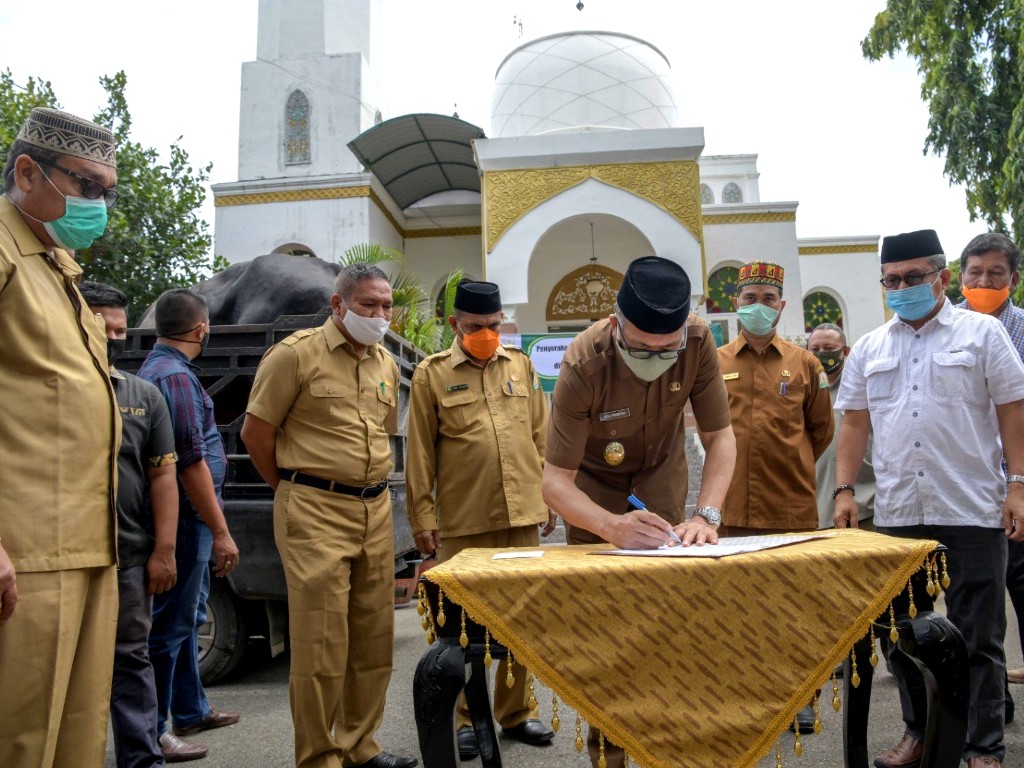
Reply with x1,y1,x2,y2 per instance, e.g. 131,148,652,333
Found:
426,530,937,768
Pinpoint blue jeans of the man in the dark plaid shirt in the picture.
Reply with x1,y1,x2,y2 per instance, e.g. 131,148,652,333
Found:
150,514,213,736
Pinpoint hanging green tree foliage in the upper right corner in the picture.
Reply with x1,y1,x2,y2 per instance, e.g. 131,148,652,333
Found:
861,0,1024,242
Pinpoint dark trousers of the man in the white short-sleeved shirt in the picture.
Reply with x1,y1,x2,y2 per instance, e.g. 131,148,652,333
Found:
878,525,1007,762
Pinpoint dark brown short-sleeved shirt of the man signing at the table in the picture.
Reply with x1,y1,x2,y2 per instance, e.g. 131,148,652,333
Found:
545,314,729,543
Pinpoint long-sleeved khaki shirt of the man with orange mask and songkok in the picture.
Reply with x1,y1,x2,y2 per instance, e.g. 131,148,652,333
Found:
406,340,548,537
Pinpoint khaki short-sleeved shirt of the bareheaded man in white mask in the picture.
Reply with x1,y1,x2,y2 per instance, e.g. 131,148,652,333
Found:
247,317,398,485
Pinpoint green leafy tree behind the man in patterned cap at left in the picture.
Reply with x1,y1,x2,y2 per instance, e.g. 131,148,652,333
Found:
0,70,220,319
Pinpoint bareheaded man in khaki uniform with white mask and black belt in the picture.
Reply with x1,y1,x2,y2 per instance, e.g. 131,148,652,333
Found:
242,264,417,768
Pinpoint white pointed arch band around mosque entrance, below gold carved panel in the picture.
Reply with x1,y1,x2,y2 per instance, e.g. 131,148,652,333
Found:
486,178,702,313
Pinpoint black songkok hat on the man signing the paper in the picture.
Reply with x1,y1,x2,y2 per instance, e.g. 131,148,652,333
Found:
617,256,690,334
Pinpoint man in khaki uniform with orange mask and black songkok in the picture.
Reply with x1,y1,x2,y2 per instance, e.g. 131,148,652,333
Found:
406,281,555,760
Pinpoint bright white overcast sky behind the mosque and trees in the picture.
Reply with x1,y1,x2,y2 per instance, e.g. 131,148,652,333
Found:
0,0,984,258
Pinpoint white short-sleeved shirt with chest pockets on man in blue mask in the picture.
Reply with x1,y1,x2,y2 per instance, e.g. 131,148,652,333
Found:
836,299,1024,528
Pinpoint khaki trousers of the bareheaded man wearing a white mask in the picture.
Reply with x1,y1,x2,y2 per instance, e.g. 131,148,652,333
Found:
273,481,394,768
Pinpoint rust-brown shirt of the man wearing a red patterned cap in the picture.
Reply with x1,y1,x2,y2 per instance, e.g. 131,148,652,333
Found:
718,334,835,529
